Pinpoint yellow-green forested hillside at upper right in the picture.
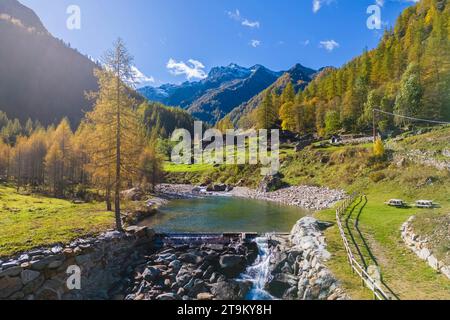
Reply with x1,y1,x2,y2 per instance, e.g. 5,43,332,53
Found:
246,0,450,135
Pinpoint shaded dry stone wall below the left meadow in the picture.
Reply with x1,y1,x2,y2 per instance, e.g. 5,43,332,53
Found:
0,227,154,300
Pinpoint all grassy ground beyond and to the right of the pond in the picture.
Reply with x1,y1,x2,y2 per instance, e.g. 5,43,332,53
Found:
169,128,450,299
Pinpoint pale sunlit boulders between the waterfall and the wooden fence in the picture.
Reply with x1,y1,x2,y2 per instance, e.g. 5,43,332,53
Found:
266,217,349,300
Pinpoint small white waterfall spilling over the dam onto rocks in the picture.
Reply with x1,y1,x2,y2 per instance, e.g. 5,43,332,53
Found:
241,236,275,300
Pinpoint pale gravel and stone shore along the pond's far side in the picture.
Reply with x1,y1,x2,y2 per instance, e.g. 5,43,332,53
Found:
157,184,347,210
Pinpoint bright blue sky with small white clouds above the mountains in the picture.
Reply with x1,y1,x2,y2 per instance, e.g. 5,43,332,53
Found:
19,0,417,86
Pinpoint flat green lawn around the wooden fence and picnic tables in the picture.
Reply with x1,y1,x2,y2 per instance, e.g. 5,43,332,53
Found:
317,174,450,299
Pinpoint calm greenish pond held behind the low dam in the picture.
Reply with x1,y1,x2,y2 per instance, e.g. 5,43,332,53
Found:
141,197,311,234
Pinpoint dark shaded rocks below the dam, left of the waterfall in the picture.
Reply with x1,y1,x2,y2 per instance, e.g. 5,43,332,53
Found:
126,242,258,300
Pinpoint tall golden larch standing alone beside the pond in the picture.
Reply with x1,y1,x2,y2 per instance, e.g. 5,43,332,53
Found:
87,39,143,230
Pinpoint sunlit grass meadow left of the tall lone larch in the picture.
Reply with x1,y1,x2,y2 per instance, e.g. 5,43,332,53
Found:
0,185,114,257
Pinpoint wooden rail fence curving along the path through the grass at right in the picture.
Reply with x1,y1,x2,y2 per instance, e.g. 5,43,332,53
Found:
336,195,390,300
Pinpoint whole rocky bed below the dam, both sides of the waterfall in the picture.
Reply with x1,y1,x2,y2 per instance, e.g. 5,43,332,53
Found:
121,217,348,300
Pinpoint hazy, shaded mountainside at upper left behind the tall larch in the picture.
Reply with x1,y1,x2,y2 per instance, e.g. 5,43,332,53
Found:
0,0,97,125
